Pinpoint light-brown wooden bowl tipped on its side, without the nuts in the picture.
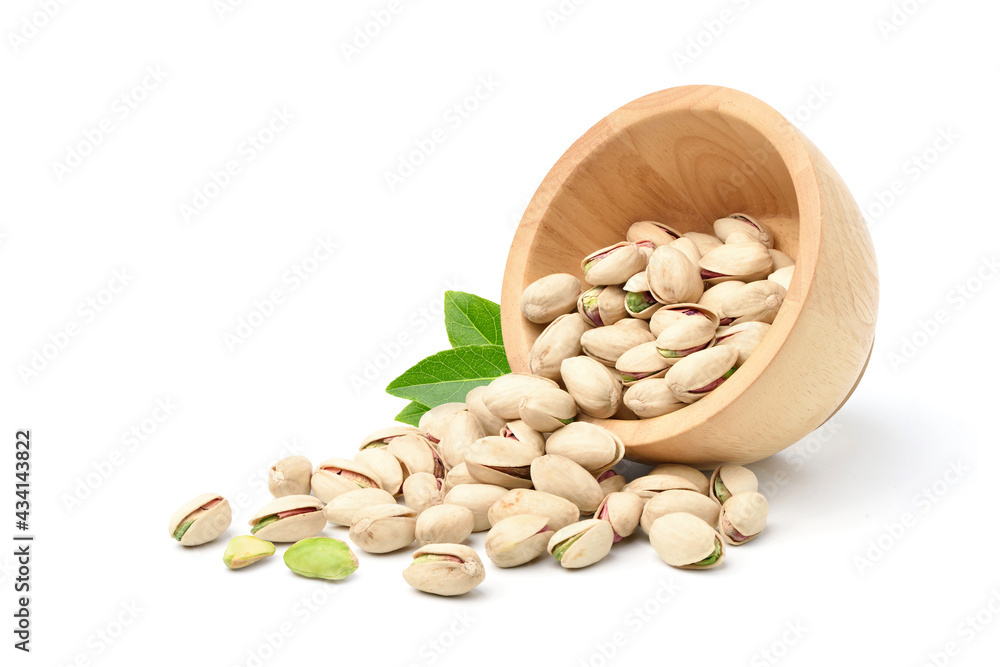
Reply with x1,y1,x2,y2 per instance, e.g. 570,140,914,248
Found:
502,86,878,467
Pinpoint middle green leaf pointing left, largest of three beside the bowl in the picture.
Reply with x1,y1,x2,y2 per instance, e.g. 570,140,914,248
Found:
385,345,510,408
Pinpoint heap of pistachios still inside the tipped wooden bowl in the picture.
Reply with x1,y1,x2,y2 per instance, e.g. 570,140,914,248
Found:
521,213,795,419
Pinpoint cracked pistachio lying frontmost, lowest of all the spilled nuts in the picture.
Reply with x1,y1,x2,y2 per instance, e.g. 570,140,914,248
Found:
403,544,486,596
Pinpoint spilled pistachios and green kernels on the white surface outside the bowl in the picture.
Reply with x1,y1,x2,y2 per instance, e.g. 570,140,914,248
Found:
169,374,768,596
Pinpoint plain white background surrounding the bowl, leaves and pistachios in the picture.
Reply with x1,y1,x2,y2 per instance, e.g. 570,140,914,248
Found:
0,0,1000,666
